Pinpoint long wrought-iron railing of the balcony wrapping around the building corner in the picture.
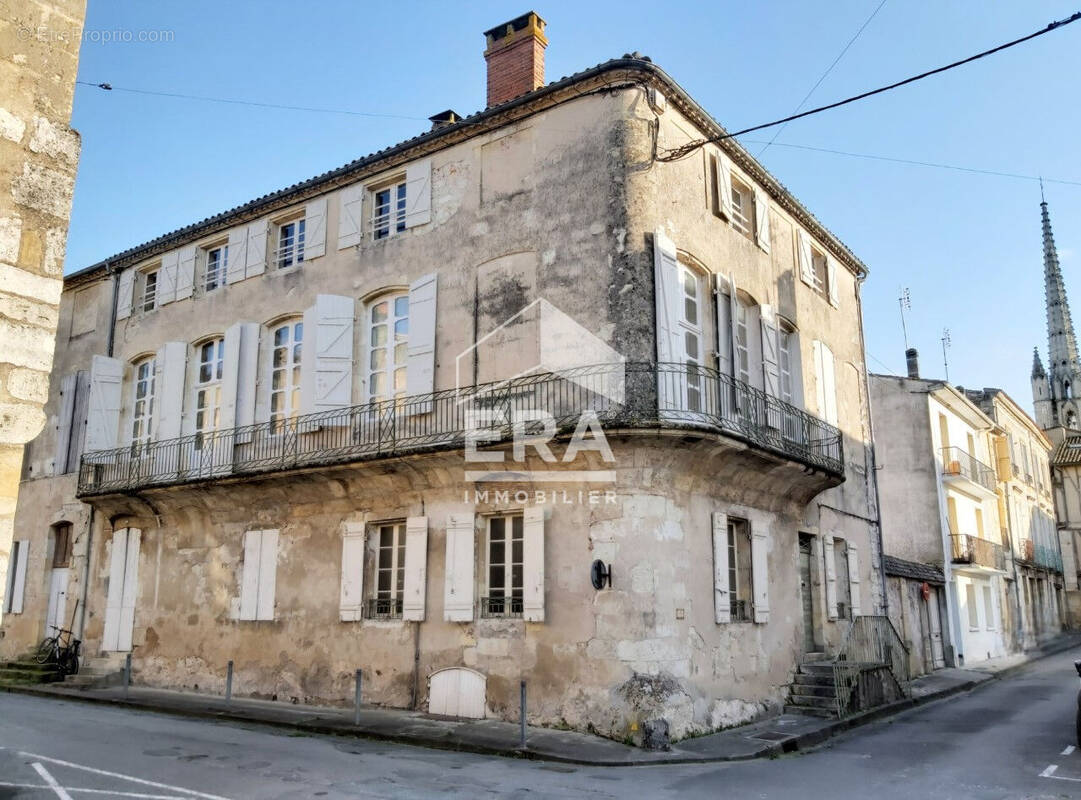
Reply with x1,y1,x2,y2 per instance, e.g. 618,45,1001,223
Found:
78,362,844,496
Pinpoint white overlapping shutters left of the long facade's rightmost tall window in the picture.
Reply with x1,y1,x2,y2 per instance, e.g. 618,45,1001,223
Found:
301,294,356,414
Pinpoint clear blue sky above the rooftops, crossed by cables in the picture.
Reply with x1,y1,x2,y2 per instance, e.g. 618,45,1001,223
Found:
66,0,1081,409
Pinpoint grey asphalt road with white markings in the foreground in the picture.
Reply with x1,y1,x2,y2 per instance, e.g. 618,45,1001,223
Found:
0,651,1081,800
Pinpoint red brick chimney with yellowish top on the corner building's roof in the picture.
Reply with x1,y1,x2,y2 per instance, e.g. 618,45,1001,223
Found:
484,11,548,108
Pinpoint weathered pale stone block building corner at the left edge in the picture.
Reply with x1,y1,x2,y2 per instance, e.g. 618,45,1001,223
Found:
0,0,85,627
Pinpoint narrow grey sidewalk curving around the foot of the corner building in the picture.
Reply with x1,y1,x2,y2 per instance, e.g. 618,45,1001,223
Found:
4,634,1081,766
